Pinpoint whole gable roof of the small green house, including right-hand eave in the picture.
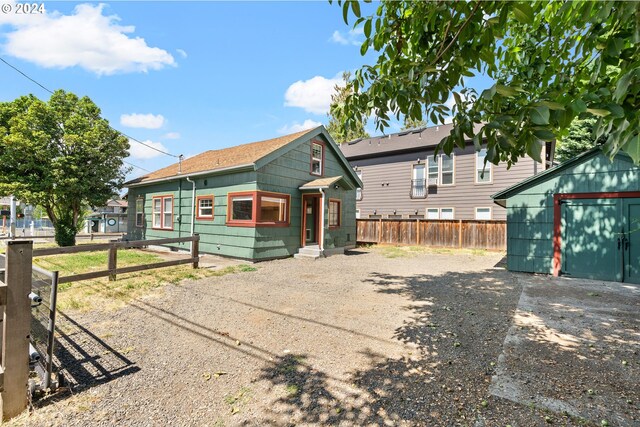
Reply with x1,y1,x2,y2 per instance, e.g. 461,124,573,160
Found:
124,126,362,187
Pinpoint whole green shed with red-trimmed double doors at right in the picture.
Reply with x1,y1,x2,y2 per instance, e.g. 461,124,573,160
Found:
491,148,640,283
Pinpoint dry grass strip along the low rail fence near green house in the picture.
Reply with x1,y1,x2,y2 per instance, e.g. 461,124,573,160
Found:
33,249,256,311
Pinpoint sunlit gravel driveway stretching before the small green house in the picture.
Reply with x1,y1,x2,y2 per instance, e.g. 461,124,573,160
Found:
16,250,636,427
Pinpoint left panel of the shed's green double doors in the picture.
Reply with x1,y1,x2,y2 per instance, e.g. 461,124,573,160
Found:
561,199,622,281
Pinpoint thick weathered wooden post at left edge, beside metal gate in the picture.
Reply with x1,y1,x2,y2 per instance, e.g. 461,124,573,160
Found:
0,240,33,420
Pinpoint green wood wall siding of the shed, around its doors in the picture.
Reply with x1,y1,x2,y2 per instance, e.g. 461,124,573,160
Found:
507,153,640,273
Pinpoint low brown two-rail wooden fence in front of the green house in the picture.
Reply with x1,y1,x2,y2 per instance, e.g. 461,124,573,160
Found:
33,234,200,283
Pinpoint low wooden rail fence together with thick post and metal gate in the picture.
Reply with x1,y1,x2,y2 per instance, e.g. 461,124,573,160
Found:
0,234,200,420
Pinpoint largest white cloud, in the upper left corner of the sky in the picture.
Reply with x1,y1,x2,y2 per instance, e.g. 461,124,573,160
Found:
0,2,176,75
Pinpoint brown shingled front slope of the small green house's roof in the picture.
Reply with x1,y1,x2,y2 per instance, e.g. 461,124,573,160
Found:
125,129,314,185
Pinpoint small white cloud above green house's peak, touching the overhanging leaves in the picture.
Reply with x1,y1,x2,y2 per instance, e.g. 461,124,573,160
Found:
284,73,342,114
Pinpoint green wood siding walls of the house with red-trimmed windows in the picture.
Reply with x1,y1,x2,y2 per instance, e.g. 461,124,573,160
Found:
128,134,356,260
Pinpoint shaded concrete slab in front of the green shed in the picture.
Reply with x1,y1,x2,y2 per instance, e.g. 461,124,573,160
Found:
490,274,640,426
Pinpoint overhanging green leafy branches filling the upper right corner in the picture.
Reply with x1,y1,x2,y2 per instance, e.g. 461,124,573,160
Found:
330,0,640,165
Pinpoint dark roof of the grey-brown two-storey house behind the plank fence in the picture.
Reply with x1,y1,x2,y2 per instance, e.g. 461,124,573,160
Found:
340,124,481,160
